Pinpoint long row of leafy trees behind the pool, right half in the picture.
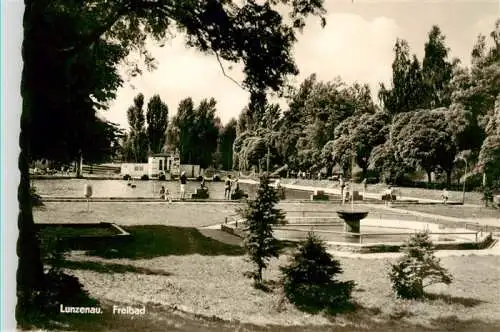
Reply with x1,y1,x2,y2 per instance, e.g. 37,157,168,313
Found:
233,21,500,191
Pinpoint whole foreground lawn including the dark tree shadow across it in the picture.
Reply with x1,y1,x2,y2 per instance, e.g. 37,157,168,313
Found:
28,225,500,331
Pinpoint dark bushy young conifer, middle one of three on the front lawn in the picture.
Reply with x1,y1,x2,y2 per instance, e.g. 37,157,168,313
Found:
281,233,355,311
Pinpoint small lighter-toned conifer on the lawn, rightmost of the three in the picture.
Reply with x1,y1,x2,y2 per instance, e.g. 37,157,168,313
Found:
389,232,452,299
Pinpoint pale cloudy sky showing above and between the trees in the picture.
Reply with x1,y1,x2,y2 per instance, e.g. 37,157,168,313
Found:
102,0,500,129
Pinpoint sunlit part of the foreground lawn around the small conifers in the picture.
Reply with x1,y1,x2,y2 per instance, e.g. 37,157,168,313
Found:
59,255,500,331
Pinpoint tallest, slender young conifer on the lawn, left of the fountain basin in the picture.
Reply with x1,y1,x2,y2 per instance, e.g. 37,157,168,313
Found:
239,175,285,286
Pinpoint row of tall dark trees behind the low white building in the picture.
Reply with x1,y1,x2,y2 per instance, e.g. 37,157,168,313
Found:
121,94,236,169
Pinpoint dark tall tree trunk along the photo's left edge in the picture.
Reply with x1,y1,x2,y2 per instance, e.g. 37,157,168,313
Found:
16,1,45,321
